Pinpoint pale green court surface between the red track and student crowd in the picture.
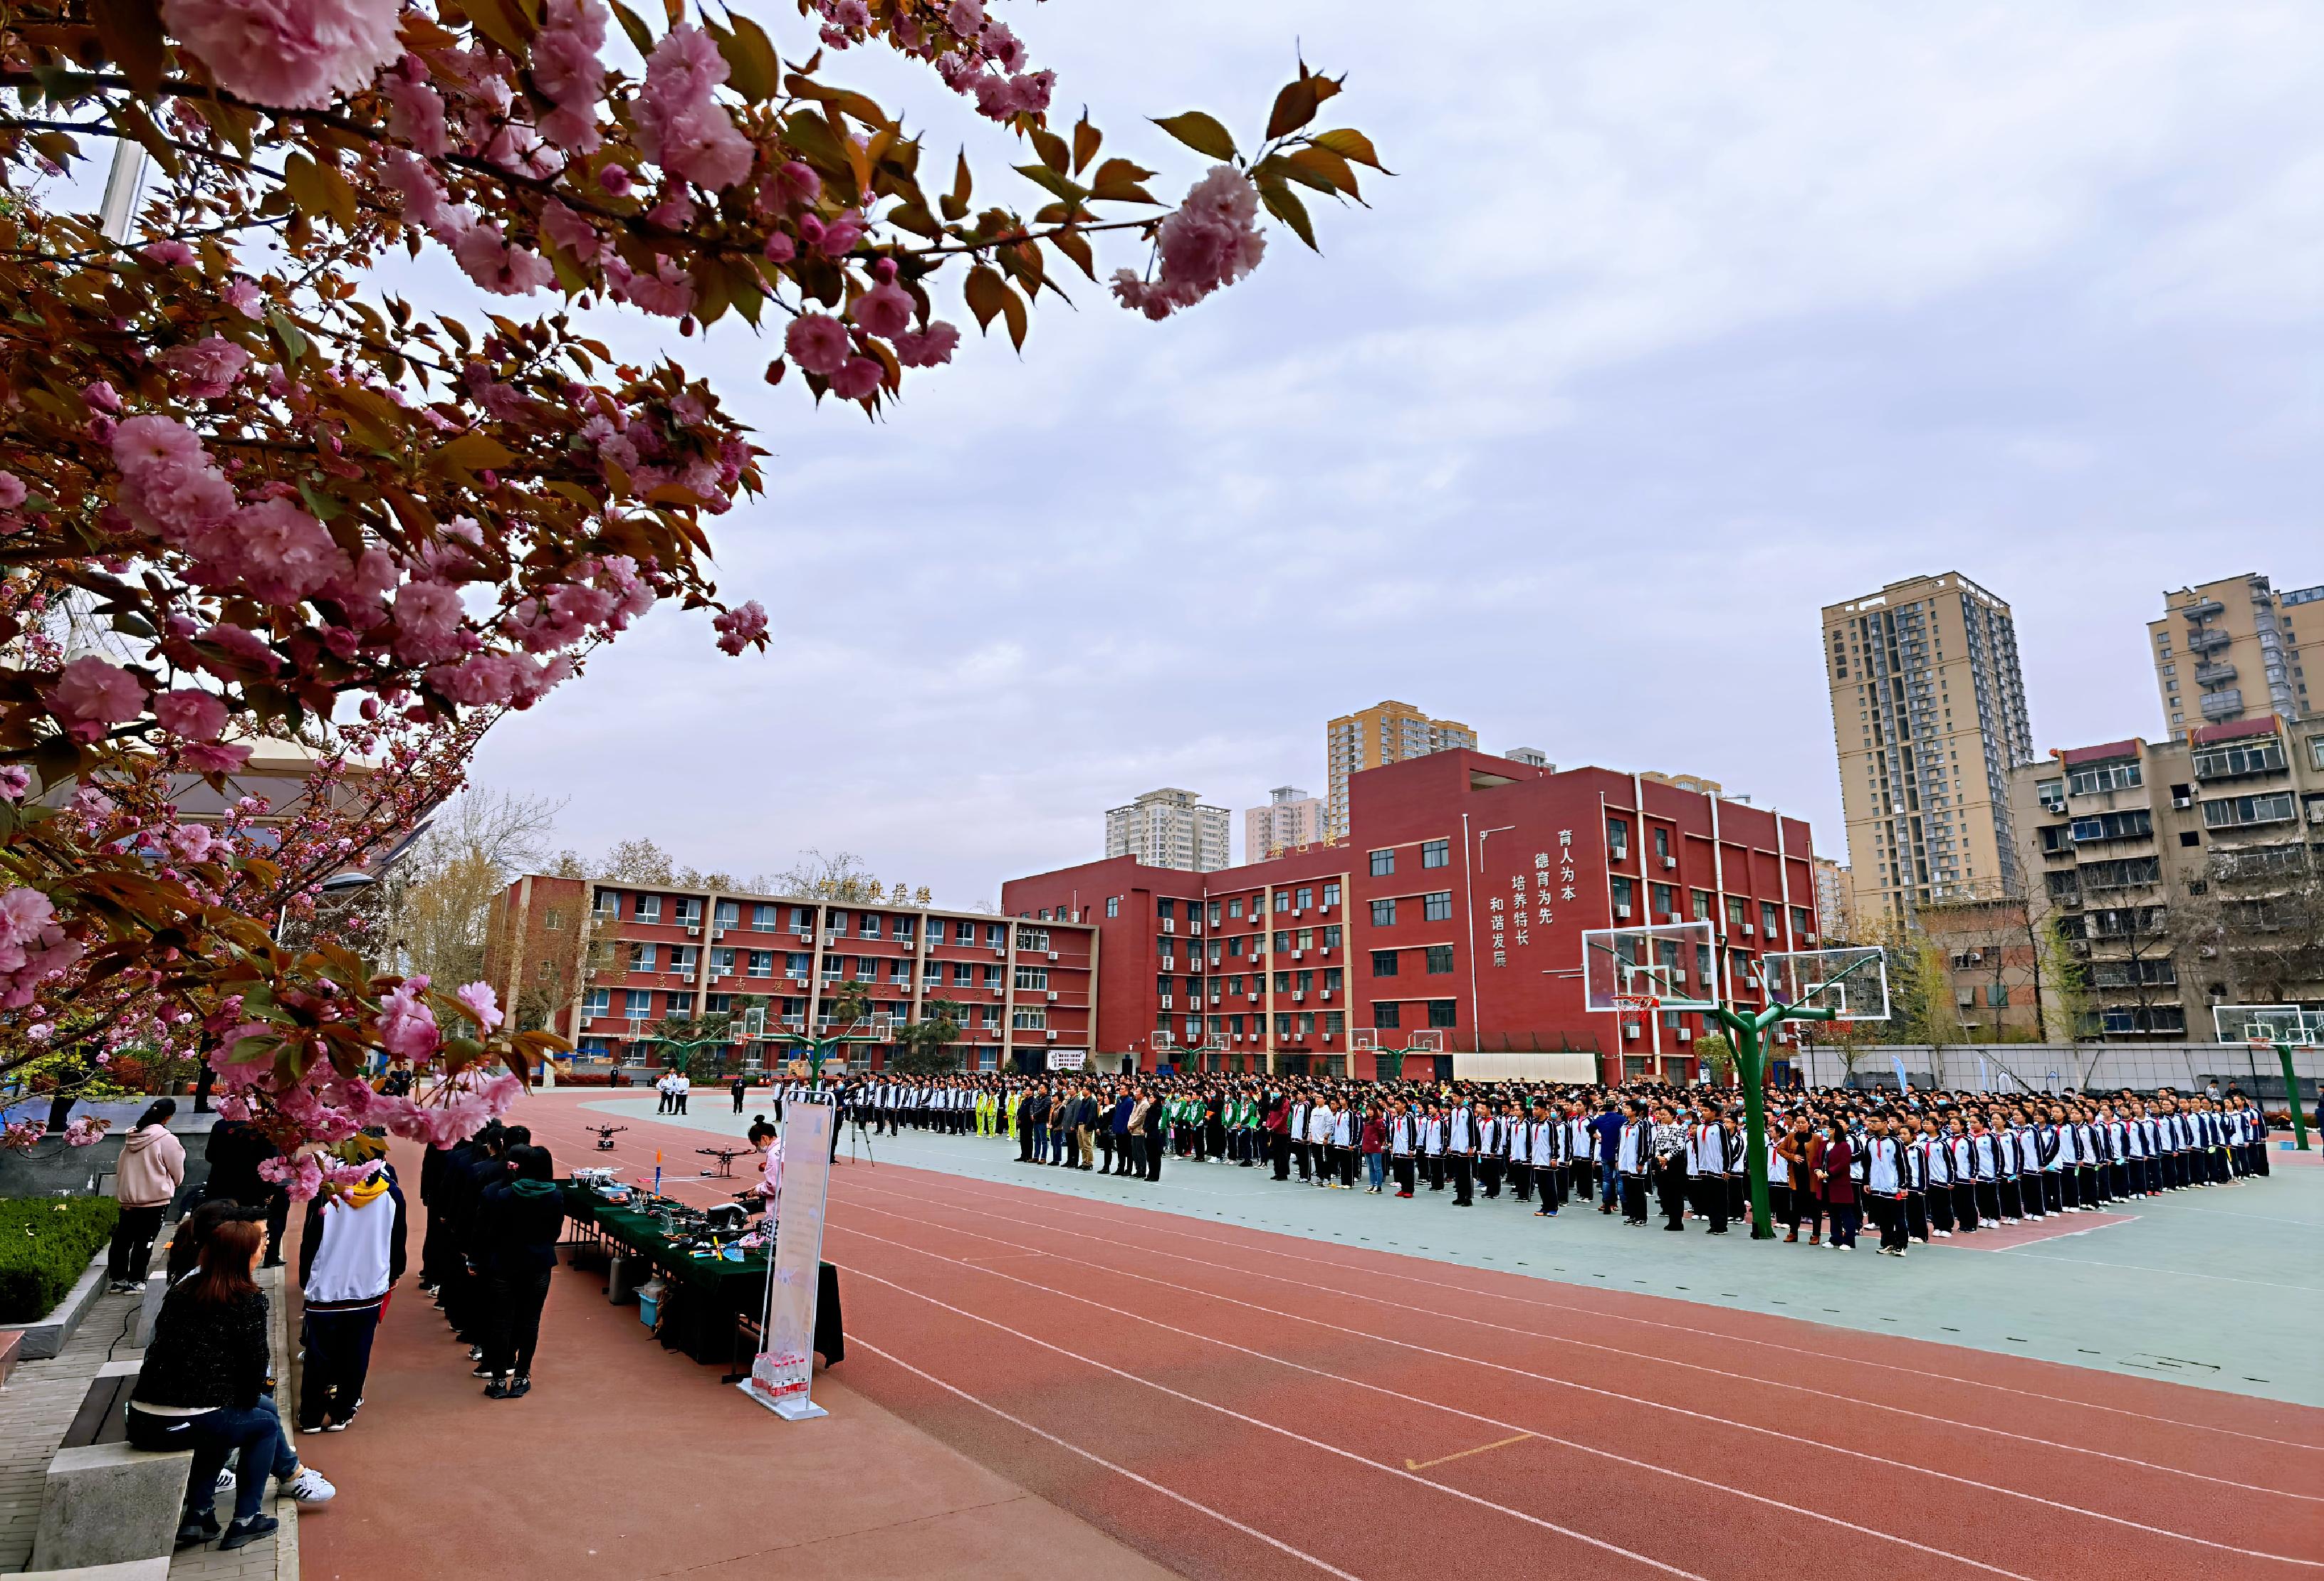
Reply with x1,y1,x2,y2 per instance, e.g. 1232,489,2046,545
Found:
571,1091,2324,1404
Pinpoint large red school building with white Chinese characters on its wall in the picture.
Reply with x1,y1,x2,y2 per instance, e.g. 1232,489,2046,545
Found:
1002,751,1822,1081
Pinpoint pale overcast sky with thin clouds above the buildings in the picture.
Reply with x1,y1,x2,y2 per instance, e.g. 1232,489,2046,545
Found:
458,0,2324,905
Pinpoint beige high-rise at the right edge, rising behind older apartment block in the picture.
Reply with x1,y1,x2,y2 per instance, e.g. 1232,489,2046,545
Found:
2147,574,2324,742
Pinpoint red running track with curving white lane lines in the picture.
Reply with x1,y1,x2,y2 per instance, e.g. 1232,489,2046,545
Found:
508,1097,2324,1581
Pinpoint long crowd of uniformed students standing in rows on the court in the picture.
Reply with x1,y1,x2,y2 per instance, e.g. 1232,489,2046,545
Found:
837,1074,2268,1258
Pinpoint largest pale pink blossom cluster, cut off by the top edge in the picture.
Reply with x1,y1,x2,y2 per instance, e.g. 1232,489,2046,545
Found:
160,0,402,110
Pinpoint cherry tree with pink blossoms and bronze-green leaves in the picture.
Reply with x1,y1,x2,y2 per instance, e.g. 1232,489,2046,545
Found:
0,0,1378,1172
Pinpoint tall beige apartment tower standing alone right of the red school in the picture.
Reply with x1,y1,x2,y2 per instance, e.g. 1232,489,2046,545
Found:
1824,572,2034,928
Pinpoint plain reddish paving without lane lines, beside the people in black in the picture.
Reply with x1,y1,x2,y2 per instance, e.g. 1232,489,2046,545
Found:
302,1134,1169,1581
